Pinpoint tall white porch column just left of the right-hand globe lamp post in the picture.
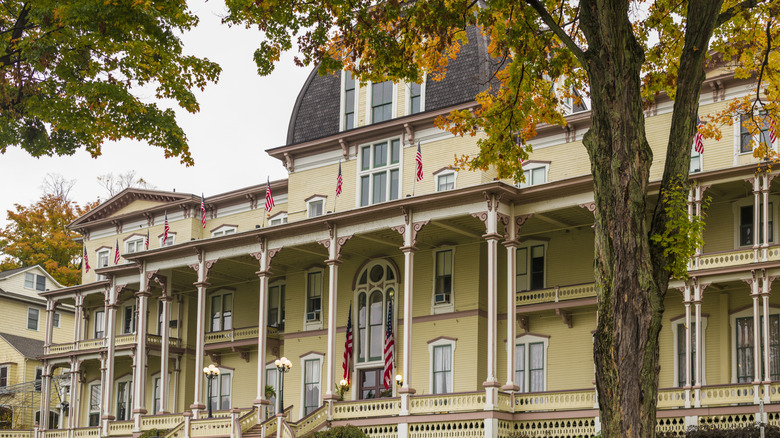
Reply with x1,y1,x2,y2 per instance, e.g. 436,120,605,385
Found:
250,238,281,422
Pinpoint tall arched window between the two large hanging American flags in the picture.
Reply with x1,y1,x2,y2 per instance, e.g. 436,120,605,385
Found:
355,260,398,362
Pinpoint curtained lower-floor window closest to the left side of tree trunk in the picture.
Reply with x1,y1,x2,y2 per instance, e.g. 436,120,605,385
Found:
515,334,549,392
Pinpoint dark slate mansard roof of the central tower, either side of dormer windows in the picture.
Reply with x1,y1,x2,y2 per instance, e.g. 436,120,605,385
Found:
287,27,488,145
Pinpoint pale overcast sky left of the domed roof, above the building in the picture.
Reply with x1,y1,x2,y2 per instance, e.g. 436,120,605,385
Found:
0,0,310,217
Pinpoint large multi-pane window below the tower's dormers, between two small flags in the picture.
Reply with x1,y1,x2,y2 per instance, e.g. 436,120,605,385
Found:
359,139,401,206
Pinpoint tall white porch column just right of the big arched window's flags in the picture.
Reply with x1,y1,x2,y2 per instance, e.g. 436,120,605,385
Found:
392,209,428,415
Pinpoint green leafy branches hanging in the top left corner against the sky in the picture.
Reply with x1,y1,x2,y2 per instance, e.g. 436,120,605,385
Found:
0,0,221,165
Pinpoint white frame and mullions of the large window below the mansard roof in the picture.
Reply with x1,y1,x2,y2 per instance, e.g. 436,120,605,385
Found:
355,136,404,208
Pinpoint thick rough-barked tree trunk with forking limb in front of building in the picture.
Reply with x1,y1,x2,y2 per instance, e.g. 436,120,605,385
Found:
581,0,722,438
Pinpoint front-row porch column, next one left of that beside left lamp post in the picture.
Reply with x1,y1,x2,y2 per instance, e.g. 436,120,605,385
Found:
133,263,153,432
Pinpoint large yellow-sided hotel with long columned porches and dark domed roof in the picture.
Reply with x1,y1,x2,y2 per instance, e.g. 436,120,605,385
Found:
20,35,780,438
